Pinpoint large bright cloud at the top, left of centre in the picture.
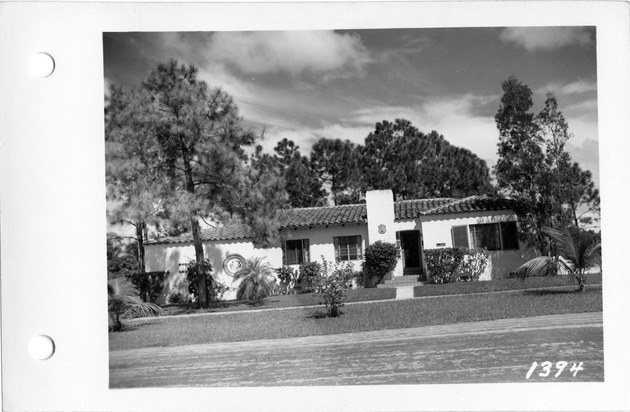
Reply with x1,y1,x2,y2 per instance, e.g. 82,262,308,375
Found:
206,31,371,75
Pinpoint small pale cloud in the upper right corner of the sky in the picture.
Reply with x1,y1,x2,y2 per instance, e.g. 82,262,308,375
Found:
500,27,594,52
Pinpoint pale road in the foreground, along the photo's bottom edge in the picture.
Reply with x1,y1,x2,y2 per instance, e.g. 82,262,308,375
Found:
110,312,604,388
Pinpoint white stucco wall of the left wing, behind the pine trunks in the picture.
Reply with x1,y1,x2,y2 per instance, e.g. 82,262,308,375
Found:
145,240,282,303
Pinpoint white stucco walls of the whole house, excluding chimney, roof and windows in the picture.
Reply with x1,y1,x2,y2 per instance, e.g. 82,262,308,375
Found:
145,212,536,303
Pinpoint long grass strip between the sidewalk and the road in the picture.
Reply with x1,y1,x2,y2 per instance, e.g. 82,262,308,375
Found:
109,285,602,350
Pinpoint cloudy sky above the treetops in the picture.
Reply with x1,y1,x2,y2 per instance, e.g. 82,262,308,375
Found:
103,27,599,186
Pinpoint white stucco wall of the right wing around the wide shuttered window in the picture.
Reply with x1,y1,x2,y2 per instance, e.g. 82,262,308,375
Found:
422,211,537,280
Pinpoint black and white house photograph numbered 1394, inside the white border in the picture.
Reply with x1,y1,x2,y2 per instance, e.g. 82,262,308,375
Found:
102,25,608,389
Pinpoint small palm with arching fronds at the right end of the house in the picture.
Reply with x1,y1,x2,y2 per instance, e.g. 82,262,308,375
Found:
516,226,602,292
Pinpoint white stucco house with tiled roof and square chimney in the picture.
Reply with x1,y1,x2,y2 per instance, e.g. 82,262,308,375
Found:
145,190,536,299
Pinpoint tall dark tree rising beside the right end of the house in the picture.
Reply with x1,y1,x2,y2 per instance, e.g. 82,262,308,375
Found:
494,77,599,255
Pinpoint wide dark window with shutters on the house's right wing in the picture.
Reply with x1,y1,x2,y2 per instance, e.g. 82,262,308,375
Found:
452,222,519,250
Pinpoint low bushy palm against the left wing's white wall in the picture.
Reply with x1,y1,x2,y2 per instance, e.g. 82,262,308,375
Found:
234,257,277,300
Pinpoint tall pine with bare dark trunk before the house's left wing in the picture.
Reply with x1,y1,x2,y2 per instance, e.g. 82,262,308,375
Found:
143,60,262,307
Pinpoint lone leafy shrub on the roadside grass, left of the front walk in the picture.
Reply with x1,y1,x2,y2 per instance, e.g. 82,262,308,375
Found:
315,256,355,318
